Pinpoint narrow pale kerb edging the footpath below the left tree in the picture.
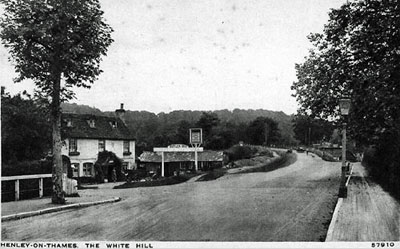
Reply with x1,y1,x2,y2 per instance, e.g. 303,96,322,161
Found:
1,197,121,222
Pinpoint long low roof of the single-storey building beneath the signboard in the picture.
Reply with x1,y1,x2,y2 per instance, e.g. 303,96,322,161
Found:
139,150,224,163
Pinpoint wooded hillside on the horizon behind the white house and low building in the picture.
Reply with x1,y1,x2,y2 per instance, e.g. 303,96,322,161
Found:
62,103,296,152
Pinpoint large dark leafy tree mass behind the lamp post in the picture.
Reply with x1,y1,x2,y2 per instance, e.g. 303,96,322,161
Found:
292,0,400,195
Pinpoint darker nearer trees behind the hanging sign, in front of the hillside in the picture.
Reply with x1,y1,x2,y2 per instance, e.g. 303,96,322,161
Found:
145,112,285,150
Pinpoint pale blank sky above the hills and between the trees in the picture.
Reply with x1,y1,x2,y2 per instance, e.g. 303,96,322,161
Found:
0,0,345,114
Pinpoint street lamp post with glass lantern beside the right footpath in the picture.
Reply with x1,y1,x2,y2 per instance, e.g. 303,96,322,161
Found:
339,98,350,198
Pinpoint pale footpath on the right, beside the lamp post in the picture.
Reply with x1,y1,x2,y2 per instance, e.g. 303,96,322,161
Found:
326,163,400,241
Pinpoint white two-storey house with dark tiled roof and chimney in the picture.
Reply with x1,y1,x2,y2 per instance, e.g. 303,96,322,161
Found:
62,104,136,178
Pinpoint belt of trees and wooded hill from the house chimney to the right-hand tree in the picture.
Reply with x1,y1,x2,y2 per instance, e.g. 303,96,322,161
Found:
108,109,296,154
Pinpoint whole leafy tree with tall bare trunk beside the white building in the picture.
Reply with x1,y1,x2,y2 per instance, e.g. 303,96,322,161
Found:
0,0,113,203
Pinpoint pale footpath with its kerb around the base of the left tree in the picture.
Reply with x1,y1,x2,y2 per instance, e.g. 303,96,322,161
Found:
1,183,121,221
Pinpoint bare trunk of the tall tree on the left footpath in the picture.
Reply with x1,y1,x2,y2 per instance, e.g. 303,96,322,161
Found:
51,73,65,204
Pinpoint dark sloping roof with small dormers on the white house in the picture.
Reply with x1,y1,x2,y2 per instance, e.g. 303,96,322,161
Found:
62,113,135,140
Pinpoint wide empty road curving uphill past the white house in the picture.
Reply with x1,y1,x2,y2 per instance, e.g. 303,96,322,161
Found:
2,154,340,241
